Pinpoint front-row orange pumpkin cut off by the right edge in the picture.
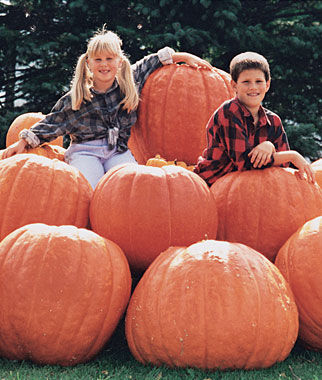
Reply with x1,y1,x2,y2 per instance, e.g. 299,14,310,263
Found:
275,216,322,351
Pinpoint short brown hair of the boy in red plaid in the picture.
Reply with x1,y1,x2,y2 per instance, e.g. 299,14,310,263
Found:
229,51,271,82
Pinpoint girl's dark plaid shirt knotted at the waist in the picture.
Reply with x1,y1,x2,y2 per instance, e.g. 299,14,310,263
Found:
20,48,166,152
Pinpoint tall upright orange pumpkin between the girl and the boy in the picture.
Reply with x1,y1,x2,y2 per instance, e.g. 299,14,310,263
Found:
129,65,234,165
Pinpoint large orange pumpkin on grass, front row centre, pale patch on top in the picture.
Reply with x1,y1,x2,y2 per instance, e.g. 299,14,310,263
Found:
126,240,298,369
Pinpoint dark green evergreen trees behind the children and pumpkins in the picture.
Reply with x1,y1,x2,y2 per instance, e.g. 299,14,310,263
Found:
0,0,322,160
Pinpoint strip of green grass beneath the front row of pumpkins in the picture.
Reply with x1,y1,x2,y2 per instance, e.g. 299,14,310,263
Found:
0,323,322,380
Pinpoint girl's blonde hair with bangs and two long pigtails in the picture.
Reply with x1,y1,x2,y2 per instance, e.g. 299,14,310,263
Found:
71,25,139,112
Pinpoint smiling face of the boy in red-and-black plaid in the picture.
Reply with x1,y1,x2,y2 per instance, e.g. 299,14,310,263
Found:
231,69,270,112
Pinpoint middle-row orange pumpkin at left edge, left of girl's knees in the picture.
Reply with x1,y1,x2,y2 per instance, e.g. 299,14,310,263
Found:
0,154,93,240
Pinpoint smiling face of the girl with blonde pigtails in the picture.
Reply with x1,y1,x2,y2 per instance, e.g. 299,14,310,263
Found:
87,52,122,92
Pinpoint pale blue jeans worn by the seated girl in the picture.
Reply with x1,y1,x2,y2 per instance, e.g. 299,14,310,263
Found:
65,139,136,189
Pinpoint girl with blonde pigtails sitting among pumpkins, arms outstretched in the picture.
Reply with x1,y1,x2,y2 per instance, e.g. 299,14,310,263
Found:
2,27,212,188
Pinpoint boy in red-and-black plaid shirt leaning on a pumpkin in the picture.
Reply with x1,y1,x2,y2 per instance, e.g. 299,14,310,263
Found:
195,52,315,186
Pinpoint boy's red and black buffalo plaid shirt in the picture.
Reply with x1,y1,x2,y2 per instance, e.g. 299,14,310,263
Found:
195,98,290,186
